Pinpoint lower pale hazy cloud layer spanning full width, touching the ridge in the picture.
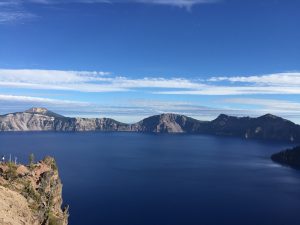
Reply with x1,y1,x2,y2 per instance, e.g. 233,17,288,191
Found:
0,94,300,123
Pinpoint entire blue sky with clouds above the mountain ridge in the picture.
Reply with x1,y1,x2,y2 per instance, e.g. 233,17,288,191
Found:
0,0,300,124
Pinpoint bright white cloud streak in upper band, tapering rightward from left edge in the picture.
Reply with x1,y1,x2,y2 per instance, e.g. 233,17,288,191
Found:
0,69,203,92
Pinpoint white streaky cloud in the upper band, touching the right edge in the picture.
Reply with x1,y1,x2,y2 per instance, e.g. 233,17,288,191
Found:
156,72,300,95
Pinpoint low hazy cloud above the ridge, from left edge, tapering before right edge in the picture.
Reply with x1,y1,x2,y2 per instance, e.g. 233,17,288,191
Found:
0,94,246,123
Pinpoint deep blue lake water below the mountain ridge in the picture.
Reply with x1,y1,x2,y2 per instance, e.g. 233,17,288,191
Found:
0,133,300,225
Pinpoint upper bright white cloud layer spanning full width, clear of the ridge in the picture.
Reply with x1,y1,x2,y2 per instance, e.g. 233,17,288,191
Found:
0,69,300,95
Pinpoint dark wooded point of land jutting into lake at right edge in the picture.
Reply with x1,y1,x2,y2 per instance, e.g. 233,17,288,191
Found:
271,146,300,169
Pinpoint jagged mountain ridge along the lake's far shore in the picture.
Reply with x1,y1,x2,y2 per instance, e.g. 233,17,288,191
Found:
0,108,300,143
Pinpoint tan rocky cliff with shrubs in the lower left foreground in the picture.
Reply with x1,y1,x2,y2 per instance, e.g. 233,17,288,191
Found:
0,157,68,225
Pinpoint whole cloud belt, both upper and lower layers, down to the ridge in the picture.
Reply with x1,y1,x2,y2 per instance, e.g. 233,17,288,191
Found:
0,69,300,123
